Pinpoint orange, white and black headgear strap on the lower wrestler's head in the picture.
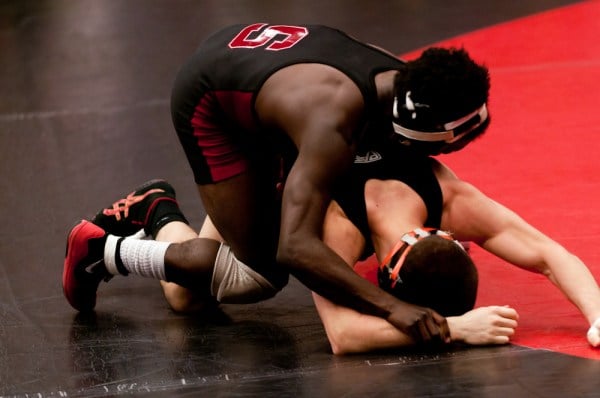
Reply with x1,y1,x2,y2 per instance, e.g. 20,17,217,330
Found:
379,228,465,289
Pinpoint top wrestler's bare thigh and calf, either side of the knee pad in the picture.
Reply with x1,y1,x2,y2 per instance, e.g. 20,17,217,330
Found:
165,161,287,287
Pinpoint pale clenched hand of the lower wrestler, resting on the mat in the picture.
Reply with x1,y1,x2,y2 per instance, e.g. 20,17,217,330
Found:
447,306,519,345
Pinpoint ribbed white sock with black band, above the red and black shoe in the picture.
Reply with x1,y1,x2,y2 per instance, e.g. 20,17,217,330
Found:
104,235,171,280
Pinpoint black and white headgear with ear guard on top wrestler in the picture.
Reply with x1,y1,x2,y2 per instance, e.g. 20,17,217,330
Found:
392,91,489,144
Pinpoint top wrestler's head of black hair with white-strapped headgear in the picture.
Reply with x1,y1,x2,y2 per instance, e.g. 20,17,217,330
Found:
393,47,490,155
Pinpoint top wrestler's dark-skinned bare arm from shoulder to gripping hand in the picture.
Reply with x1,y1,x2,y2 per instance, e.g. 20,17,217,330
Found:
256,65,449,342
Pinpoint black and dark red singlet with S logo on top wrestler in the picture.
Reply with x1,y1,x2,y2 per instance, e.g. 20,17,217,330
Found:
171,24,404,184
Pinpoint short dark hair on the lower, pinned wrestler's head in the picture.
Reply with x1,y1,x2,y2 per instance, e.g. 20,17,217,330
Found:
379,235,479,316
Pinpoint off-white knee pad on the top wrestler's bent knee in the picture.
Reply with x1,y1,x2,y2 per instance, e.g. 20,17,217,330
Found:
210,243,279,304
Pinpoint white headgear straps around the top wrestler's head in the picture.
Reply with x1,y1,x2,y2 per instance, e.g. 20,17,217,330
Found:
392,91,488,144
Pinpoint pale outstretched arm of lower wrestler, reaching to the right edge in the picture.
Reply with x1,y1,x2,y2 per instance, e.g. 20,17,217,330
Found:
436,160,600,344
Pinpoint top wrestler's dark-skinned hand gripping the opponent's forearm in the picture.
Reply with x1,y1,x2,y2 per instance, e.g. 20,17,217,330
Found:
387,302,451,344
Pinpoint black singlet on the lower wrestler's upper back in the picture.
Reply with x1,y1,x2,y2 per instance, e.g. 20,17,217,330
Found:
333,146,443,259
